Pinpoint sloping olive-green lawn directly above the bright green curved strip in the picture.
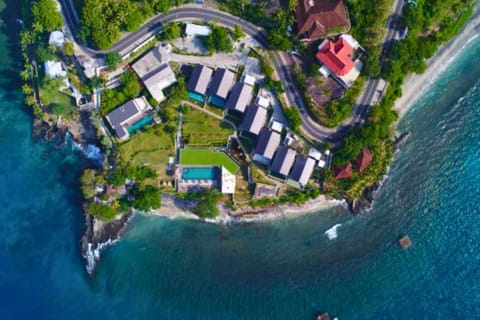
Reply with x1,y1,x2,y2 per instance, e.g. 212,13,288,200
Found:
182,106,233,147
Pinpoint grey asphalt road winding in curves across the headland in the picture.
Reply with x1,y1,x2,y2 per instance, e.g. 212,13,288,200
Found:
59,0,403,143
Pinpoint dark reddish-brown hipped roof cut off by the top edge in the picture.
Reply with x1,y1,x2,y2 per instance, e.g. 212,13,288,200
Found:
295,0,350,41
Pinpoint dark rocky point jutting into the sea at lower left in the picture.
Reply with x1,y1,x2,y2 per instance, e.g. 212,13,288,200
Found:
81,209,133,274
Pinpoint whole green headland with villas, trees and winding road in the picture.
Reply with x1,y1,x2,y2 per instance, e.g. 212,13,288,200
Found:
20,0,474,274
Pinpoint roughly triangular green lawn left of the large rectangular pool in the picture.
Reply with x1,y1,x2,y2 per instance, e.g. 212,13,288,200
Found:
118,124,175,180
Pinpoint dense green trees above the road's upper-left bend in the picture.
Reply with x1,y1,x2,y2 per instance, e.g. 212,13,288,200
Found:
79,0,183,49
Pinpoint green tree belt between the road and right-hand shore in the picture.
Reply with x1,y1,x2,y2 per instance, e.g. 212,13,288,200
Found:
325,0,473,199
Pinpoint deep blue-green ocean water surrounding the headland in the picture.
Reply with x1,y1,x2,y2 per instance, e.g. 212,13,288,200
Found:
0,1,480,320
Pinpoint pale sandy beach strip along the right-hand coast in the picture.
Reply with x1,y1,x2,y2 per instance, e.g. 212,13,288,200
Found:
394,5,480,118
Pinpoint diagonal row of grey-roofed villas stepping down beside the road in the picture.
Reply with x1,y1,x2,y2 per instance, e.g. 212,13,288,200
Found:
187,65,330,189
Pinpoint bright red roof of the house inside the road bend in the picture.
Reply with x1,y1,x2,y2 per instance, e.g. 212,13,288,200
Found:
317,38,355,77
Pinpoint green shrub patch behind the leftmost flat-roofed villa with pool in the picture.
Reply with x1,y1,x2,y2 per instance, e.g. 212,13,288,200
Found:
100,71,140,115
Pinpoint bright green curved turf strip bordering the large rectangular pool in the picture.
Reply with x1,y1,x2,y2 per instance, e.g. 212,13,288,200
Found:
180,149,239,174
